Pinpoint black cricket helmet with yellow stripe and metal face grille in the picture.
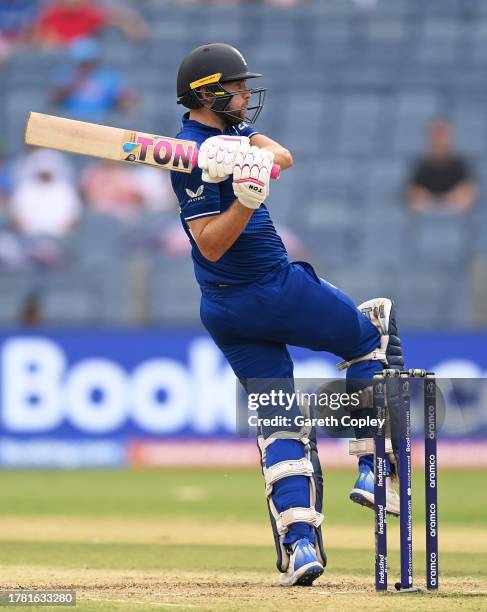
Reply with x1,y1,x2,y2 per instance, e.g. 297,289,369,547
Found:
178,43,266,125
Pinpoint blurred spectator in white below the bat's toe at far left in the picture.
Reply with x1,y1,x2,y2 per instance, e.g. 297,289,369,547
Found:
8,149,81,237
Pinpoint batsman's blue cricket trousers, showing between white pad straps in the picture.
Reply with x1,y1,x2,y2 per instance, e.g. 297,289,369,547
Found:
200,262,379,544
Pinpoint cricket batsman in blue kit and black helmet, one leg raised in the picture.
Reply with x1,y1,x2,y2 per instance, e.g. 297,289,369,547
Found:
171,43,403,586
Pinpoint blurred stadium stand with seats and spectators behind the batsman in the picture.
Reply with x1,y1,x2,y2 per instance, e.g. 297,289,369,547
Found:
0,0,487,329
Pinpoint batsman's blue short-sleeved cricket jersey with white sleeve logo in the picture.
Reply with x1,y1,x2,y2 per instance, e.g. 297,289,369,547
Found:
171,113,288,288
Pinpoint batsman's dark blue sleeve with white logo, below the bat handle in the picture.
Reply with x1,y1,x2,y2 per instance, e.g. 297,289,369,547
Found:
171,168,220,221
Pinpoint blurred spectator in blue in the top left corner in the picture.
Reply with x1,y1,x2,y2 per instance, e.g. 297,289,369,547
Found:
0,0,40,65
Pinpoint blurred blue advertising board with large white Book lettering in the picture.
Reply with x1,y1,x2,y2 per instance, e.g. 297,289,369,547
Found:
0,330,487,468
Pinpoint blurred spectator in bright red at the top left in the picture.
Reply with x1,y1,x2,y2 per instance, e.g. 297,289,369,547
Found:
35,0,148,46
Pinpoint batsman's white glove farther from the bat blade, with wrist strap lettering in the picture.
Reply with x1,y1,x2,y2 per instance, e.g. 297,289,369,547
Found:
233,147,274,209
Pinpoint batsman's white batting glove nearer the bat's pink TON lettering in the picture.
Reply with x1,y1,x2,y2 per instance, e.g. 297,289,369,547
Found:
198,135,250,183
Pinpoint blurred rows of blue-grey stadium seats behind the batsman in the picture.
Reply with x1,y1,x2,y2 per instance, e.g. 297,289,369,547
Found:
0,0,487,328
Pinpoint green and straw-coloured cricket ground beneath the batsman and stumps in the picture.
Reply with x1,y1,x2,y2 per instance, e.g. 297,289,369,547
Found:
0,468,487,611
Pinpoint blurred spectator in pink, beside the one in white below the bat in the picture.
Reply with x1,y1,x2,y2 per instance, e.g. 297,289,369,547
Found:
81,161,145,221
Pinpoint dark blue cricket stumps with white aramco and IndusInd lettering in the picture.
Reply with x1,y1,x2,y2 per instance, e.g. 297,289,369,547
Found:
373,369,438,593
